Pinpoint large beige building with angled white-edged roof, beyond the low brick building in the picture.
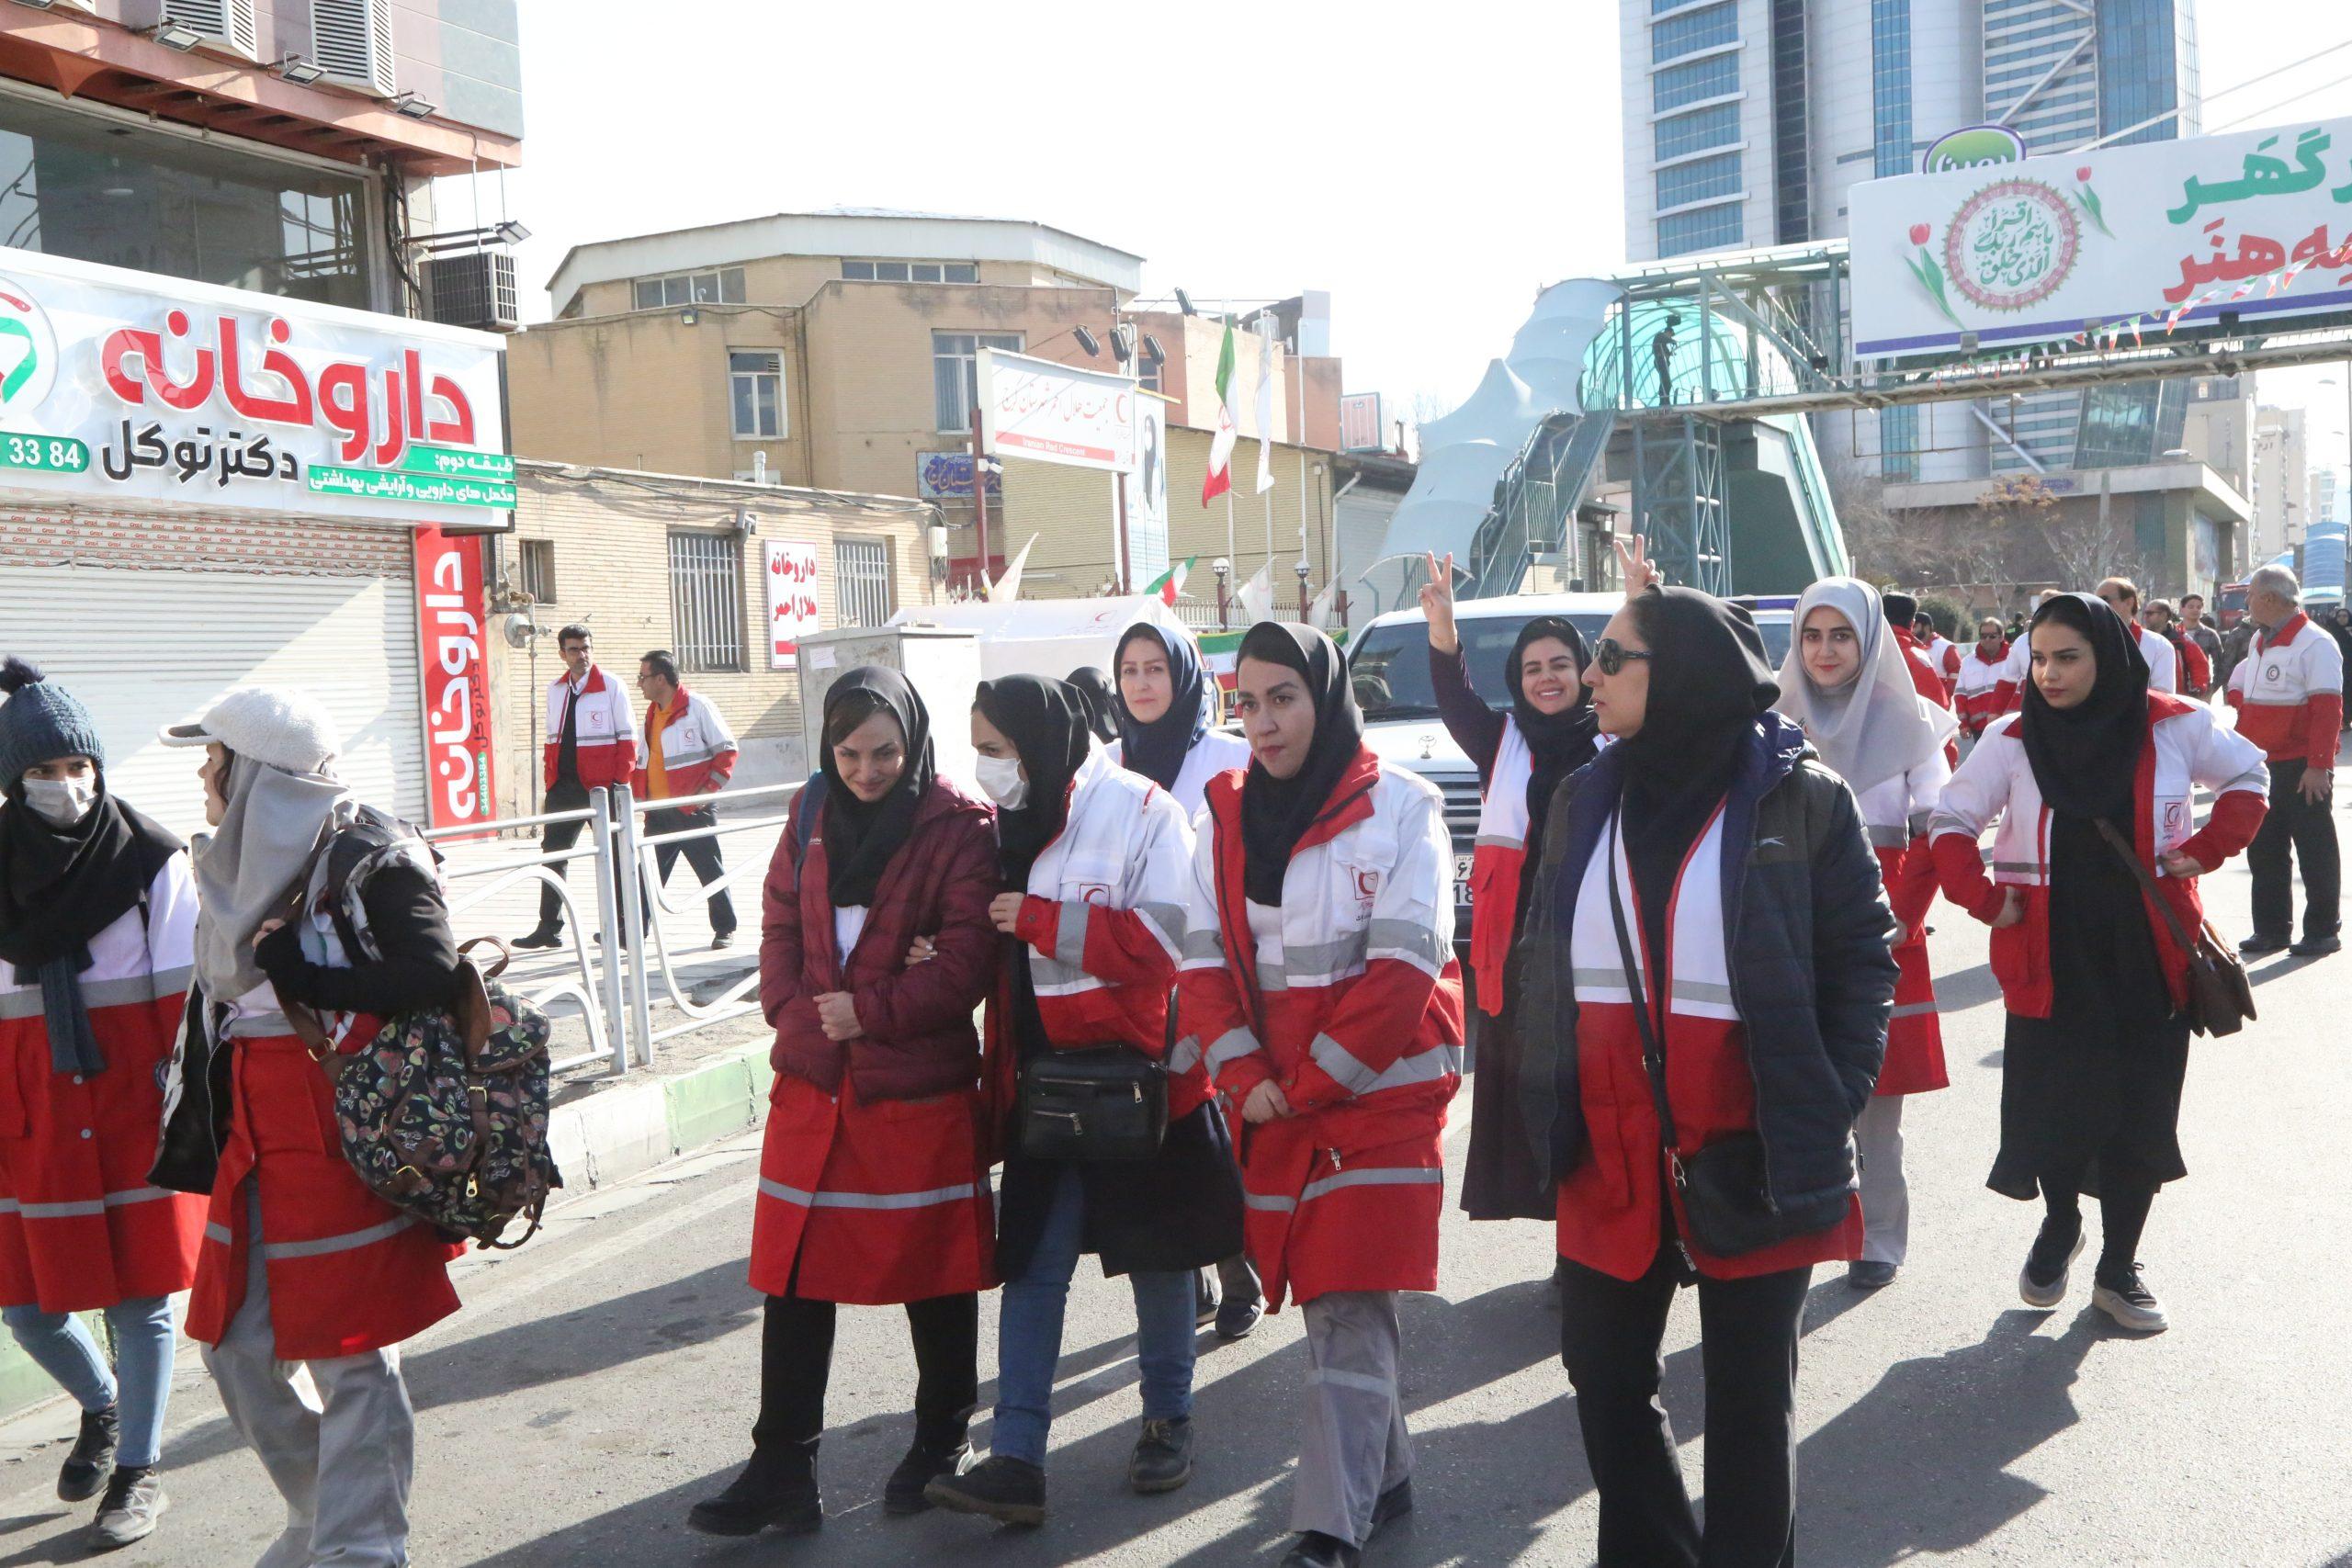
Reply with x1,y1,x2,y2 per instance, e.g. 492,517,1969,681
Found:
508,209,1340,592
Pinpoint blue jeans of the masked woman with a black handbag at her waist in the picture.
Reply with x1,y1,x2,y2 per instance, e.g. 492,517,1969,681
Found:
988,1166,1194,1467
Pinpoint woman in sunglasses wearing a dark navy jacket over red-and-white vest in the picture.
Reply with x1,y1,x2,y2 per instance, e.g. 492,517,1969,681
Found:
1520,588,1895,1568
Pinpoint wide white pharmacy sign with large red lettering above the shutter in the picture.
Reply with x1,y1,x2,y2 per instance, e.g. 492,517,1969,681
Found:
0,249,515,529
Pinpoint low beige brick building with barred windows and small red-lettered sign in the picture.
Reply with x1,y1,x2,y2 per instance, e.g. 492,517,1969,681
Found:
489,461,936,816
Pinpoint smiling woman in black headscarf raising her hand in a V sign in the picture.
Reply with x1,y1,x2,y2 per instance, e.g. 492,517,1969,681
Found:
1420,555,1600,1220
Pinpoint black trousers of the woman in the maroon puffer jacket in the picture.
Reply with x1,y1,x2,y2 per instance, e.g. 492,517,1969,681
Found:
751,1293,981,1472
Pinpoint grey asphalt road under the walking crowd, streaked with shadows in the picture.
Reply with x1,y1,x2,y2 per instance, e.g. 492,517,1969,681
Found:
0,818,2352,1568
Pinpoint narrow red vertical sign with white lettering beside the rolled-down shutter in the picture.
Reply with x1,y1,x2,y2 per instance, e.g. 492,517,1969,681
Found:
416,529,494,828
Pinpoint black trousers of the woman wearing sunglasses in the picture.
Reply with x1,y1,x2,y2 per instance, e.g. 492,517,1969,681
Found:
1559,1246,1814,1568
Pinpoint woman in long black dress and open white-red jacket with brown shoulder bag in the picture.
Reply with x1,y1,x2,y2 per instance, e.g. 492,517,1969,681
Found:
1928,592,2269,1333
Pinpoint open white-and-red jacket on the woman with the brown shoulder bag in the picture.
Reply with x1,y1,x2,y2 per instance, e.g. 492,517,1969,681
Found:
1928,691,2269,1018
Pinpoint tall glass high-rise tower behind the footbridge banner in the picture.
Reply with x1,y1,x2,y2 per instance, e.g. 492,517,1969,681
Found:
1618,0,2199,482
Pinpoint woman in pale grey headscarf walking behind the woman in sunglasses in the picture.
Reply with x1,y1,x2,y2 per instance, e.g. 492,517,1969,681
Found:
1773,576,1954,1291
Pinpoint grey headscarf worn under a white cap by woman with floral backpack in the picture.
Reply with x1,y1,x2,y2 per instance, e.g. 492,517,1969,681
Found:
193,755,353,1001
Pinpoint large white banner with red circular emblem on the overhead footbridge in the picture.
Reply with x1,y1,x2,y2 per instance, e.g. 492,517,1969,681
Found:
1851,120,2352,355
